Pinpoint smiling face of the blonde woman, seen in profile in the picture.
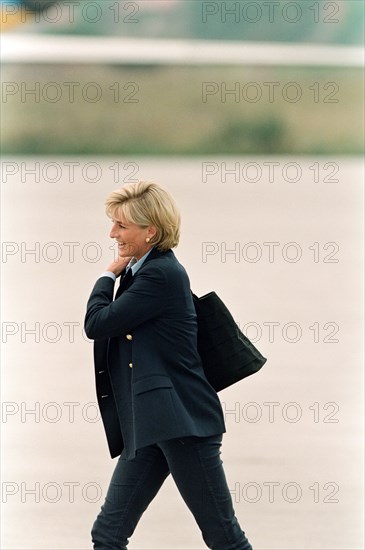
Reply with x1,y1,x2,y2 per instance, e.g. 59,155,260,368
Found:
109,212,156,260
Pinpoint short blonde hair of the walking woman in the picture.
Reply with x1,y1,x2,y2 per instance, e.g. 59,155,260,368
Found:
105,181,180,251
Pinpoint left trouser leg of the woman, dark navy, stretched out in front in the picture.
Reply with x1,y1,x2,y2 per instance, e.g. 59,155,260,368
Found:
91,445,169,550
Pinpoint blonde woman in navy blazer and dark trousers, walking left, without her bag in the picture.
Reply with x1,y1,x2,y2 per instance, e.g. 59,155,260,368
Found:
85,181,252,550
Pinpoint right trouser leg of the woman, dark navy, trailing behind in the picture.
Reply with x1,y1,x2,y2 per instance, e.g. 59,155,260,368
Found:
158,435,252,550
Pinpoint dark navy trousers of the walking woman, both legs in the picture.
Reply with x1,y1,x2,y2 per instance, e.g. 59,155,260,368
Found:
91,434,252,550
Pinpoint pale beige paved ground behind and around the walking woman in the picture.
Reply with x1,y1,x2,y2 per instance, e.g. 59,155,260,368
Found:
2,157,364,550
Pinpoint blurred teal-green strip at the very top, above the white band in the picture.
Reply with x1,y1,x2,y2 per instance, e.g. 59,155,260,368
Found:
26,0,364,44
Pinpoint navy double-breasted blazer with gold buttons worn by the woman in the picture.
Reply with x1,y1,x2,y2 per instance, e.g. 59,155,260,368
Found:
84,248,225,459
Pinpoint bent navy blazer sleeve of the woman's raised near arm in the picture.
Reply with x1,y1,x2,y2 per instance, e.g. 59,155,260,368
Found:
84,266,167,340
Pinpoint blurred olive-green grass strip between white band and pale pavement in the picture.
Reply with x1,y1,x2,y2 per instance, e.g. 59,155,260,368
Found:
2,65,363,155
